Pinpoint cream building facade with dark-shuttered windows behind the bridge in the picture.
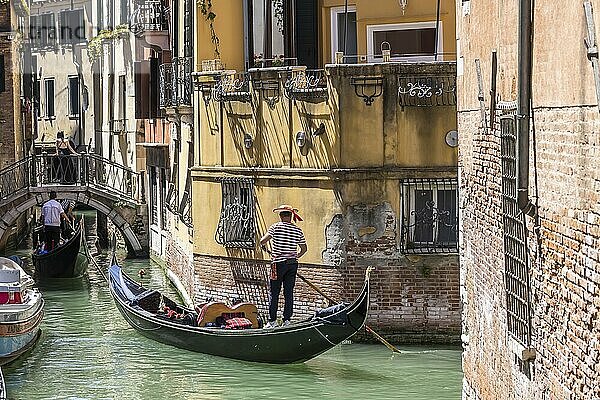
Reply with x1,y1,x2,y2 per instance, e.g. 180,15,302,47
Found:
28,0,95,152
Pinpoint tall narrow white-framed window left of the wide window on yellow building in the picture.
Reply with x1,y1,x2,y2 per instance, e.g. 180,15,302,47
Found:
331,6,358,63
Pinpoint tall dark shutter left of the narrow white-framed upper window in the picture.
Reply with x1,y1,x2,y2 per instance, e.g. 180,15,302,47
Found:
295,0,319,69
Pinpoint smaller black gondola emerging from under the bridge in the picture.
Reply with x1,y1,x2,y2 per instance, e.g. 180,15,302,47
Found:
31,218,88,279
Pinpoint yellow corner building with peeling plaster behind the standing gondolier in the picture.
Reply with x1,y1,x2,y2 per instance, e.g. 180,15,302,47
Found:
161,0,460,341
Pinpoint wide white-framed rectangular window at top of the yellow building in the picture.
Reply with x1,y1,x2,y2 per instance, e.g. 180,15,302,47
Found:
367,21,442,62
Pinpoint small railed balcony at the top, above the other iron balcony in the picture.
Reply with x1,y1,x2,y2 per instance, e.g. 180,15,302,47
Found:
129,0,169,51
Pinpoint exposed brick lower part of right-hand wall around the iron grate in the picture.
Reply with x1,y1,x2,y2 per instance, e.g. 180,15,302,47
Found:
459,107,600,400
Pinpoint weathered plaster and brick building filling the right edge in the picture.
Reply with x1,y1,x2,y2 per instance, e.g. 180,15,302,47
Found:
457,0,600,400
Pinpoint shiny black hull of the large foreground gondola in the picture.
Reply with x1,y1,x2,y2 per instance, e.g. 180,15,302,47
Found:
109,267,369,364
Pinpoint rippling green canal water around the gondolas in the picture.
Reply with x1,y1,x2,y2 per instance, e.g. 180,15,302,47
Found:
3,213,462,400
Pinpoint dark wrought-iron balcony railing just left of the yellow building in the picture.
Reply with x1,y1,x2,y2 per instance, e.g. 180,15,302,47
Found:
159,57,192,109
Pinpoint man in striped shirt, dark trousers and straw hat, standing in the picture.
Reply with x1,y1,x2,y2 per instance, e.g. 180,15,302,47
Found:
260,205,307,328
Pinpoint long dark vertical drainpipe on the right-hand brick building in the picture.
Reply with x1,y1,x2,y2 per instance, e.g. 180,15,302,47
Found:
517,0,537,216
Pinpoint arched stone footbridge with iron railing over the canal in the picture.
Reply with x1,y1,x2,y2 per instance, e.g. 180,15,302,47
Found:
0,154,149,257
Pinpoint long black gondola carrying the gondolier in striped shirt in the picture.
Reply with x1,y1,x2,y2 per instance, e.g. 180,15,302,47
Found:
108,265,370,364
